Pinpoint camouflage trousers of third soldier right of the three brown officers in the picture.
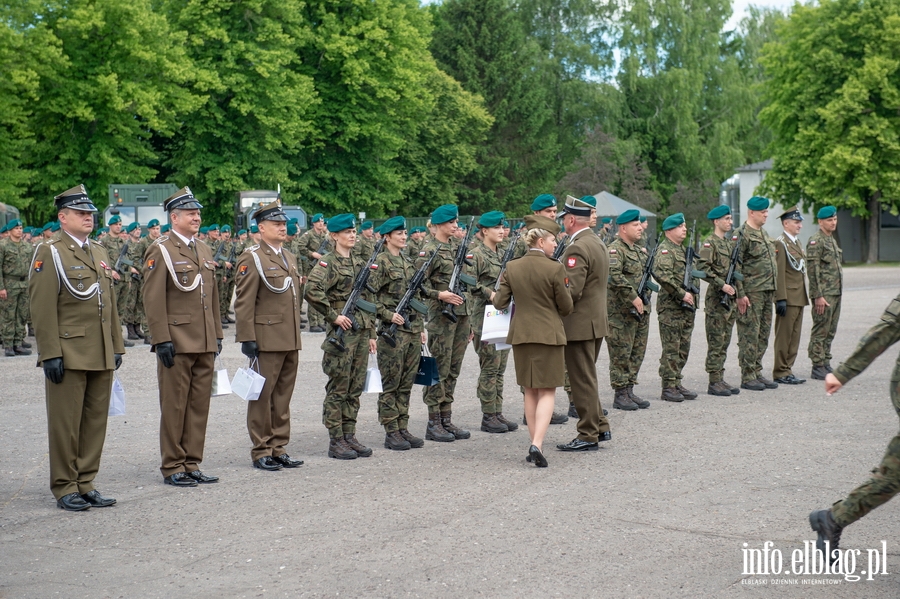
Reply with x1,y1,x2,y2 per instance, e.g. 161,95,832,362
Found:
422,313,469,414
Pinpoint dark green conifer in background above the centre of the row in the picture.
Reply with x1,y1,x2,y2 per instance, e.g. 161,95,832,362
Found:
431,0,563,213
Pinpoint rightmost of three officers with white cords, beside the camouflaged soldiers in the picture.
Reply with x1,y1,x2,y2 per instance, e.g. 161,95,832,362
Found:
234,200,303,471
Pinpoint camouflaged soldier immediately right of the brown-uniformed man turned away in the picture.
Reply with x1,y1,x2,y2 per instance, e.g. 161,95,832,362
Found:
606,210,650,411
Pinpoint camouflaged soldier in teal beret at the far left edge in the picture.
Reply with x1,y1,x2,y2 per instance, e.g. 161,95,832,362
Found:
0,219,33,356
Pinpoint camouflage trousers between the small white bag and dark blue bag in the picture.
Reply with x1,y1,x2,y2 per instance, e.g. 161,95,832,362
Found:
378,329,422,433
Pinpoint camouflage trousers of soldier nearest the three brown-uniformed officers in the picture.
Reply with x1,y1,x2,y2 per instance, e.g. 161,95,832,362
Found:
322,325,369,439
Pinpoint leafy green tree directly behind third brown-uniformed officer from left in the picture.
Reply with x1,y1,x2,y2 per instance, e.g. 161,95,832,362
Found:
161,0,319,222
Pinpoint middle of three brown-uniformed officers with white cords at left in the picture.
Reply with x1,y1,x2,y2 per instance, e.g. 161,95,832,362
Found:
144,187,224,487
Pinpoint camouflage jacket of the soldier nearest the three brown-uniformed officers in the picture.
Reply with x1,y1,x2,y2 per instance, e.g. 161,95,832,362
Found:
306,253,375,339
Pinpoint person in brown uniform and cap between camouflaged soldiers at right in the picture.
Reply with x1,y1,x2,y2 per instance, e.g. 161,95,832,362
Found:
772,206,809,385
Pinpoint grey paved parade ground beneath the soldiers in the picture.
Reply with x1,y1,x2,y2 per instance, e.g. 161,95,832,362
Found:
0,267,900,598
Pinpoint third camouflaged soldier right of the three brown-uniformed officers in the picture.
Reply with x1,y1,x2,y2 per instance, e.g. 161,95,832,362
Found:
416,204,473,442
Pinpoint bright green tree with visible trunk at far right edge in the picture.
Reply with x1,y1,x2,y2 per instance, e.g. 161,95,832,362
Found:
760,0,900,262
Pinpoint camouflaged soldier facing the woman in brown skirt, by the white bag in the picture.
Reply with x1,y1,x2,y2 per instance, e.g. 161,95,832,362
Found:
469,210,519,433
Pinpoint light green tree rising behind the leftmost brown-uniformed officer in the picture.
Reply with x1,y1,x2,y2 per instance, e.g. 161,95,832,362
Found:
20,0,196,221
